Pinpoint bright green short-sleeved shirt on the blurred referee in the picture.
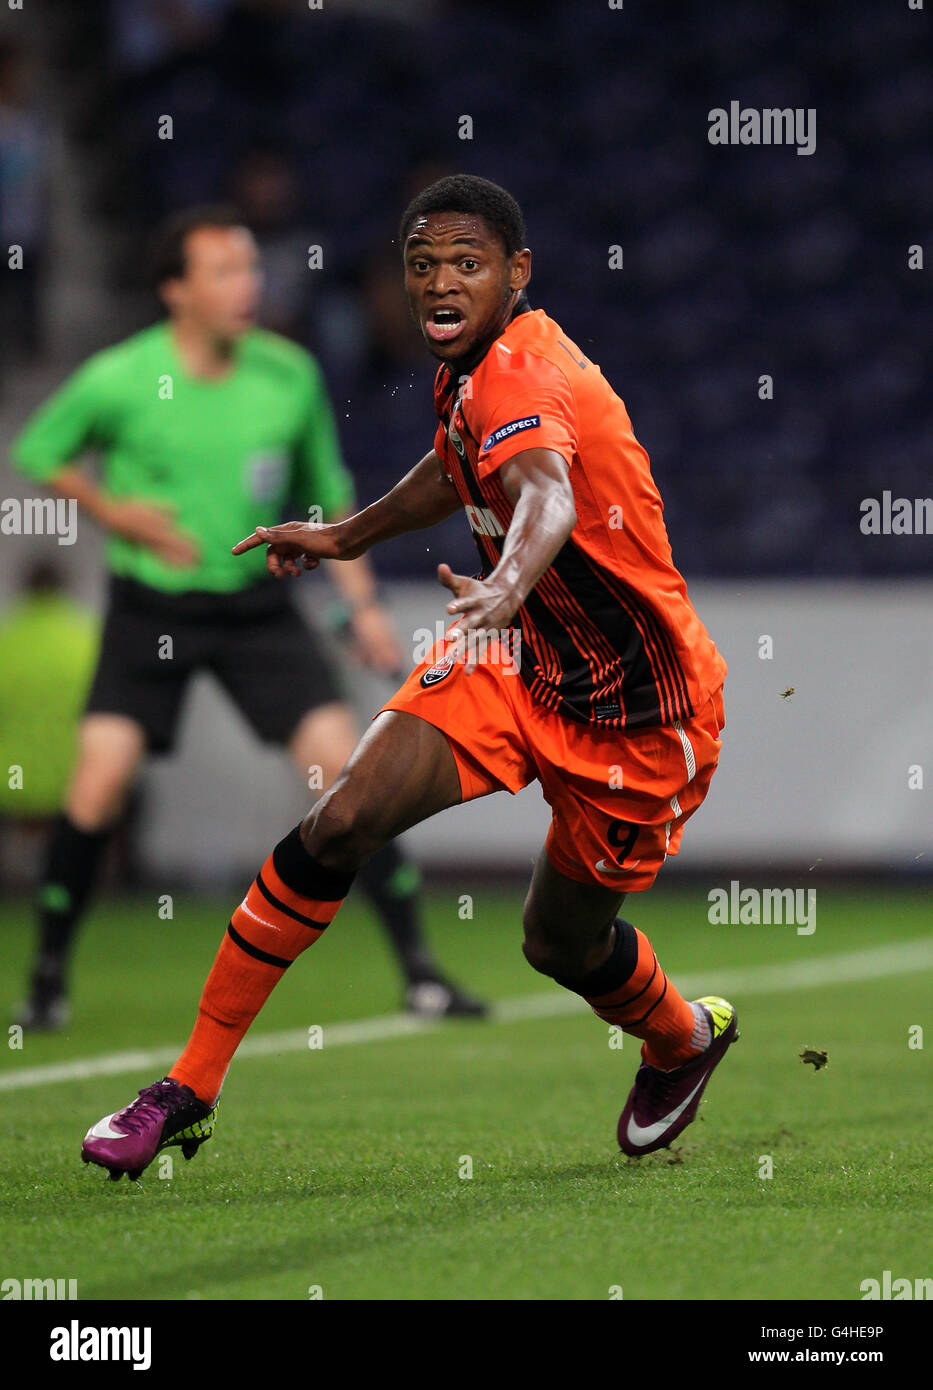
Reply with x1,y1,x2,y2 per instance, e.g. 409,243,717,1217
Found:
13,322,353,594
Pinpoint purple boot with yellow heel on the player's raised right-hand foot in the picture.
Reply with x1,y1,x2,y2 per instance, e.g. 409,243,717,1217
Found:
619,995,738,1158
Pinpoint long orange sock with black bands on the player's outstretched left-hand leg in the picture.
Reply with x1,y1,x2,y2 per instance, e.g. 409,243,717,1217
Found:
168,826,353,1104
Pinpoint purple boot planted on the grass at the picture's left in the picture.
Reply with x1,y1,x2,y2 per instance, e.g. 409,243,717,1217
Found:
81,1076,217,1182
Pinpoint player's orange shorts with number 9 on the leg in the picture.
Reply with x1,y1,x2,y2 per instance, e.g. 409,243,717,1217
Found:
382,641,724,892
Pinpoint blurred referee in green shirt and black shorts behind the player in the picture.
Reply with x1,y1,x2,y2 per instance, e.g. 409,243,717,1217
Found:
13,207,484,1029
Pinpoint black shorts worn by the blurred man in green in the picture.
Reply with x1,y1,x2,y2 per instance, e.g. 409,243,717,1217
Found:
85,575,345,753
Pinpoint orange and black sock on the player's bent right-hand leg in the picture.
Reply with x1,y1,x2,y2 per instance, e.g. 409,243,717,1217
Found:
559,917,700,1070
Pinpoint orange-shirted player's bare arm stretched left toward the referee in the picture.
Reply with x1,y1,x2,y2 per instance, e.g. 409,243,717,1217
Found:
234,449,462,575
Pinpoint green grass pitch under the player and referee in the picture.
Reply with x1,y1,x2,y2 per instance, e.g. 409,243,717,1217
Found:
0,881,933,1300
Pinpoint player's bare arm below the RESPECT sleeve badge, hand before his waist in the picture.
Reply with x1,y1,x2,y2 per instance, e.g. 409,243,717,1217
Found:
438,449,577,635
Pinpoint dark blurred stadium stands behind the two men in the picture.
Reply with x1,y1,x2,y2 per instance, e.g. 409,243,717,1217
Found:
0,0,933,577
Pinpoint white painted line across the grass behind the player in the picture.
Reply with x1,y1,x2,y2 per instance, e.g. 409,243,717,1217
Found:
0,937,933,1091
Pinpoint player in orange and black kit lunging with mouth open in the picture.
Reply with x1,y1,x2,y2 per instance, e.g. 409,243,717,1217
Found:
82,175,736,1177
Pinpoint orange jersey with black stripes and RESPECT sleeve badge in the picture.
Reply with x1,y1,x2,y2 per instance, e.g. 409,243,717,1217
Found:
434,307,726,728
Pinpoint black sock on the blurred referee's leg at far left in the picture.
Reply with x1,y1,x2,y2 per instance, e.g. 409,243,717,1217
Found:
33,813,113,992
